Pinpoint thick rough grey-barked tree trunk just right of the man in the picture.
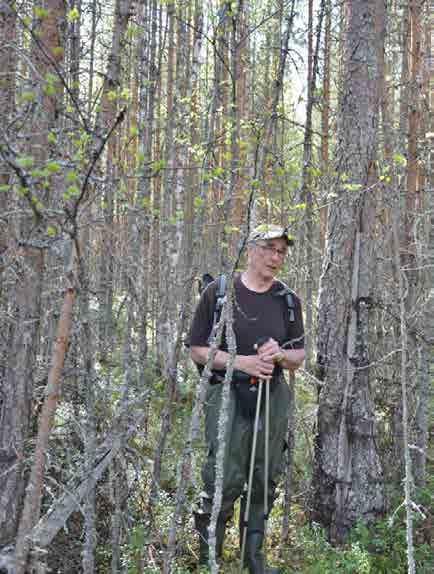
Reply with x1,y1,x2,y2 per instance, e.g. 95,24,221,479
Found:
313,0,384,542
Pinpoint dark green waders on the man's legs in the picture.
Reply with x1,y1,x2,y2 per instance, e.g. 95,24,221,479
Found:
198,376,289,574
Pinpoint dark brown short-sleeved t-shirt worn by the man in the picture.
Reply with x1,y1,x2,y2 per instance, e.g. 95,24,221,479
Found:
187,275,304,355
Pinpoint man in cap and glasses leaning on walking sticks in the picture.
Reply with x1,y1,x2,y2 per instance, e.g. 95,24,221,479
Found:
189,224,304,574
